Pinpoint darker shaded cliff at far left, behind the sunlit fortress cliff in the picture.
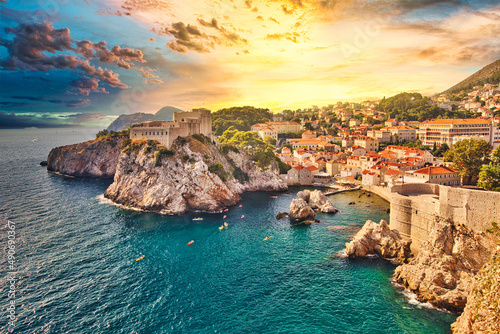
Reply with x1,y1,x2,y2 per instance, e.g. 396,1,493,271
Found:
47,137,124,178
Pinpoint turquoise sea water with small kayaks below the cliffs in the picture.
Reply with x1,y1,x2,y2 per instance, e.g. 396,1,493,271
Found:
0,129,455,333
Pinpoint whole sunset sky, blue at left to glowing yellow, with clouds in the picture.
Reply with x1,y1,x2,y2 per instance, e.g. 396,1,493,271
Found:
0,0,500,128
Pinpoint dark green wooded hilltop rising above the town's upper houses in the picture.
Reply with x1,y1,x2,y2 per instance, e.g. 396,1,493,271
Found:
377,93,468,122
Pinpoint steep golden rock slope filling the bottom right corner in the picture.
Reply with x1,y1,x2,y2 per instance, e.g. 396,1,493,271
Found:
451,247,500,334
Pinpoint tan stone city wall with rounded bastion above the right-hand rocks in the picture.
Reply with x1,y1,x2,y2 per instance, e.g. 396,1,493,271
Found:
390,184,500,252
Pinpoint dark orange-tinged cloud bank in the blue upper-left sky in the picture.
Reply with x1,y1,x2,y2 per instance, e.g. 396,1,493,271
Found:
0,22,145,95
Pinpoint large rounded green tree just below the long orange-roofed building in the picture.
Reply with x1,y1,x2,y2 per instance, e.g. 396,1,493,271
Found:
444,138,492,184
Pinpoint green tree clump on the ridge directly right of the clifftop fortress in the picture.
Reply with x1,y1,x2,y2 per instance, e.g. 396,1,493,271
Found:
212,106,273,136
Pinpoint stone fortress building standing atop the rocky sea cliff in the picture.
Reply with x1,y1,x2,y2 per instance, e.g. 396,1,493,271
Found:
130,108,212,148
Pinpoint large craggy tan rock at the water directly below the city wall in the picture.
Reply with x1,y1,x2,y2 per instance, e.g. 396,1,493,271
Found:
394,221,492,312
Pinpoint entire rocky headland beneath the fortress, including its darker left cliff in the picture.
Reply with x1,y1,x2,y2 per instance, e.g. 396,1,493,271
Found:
47,135,288,215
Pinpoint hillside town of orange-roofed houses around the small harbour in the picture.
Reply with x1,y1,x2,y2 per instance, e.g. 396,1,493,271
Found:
251,84,500,187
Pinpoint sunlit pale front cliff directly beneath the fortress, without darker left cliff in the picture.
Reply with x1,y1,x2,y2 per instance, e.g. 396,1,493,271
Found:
104,136,287,214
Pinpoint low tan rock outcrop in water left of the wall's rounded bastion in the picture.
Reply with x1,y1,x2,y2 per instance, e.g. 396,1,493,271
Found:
346,220,410,263
